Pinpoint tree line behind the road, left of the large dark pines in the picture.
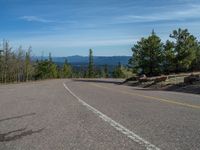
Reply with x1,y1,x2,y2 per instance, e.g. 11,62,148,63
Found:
0,40,128,83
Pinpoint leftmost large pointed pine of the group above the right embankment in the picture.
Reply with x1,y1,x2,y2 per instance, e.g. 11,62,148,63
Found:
130,31,163,76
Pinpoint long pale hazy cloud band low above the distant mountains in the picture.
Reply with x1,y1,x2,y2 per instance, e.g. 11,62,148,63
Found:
12,35,137,48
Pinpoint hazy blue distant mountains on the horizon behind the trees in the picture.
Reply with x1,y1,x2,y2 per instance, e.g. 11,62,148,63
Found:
33,55,131,66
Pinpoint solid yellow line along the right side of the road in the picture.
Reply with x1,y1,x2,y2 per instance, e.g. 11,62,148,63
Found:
92,83,200,109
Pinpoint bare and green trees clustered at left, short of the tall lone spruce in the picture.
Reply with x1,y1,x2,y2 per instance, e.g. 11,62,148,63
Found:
0,41,72,83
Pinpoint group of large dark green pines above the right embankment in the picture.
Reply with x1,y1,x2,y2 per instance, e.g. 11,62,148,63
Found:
129,29,200,76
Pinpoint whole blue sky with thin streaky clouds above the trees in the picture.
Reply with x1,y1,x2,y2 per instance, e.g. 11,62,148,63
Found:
0,0,200,56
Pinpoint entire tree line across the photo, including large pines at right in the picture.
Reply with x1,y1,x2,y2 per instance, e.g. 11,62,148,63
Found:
0,28,200,83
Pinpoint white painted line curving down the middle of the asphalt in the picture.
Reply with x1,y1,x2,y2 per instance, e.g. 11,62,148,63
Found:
63,83,160,150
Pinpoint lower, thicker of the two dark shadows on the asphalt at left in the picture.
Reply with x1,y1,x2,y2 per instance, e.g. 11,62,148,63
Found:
0,128,44,142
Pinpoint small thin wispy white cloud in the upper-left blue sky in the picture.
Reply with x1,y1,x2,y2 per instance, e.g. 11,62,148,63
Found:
20,16,54,23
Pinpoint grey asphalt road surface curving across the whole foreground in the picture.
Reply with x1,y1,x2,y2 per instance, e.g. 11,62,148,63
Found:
0,79,200,150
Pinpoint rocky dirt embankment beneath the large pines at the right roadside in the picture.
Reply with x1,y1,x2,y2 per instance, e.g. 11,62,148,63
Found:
123,72,200,94
